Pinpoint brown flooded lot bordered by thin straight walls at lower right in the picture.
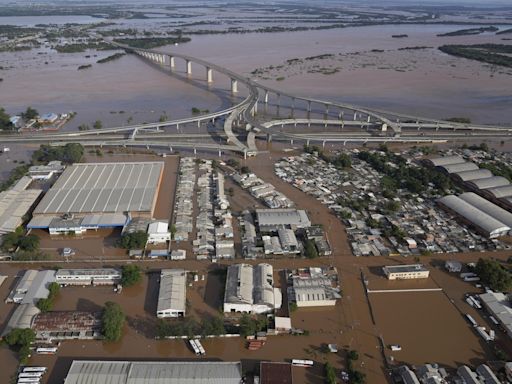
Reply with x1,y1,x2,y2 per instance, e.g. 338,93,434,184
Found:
370,292,492,368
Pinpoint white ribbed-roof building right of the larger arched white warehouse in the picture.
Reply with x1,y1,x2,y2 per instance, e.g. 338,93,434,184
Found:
288,268,341,307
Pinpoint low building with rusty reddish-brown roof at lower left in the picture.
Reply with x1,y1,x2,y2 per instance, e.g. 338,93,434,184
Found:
31,311,101,341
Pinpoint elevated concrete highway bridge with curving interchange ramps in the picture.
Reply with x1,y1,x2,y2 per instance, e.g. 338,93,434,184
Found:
9,40,512,157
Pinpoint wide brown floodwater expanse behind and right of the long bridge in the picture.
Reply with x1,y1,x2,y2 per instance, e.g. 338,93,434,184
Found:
169,25,512,124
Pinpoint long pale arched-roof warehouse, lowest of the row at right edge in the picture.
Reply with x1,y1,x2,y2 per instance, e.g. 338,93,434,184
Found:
437,195,510,239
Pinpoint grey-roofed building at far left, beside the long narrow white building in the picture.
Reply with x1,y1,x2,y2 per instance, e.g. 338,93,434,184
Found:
6,269,56,305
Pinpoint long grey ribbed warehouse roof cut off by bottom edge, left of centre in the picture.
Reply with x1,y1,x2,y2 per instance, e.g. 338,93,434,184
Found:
64,360,242,384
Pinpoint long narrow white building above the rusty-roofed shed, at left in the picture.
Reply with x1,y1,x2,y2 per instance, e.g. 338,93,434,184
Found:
55,268,122,286
